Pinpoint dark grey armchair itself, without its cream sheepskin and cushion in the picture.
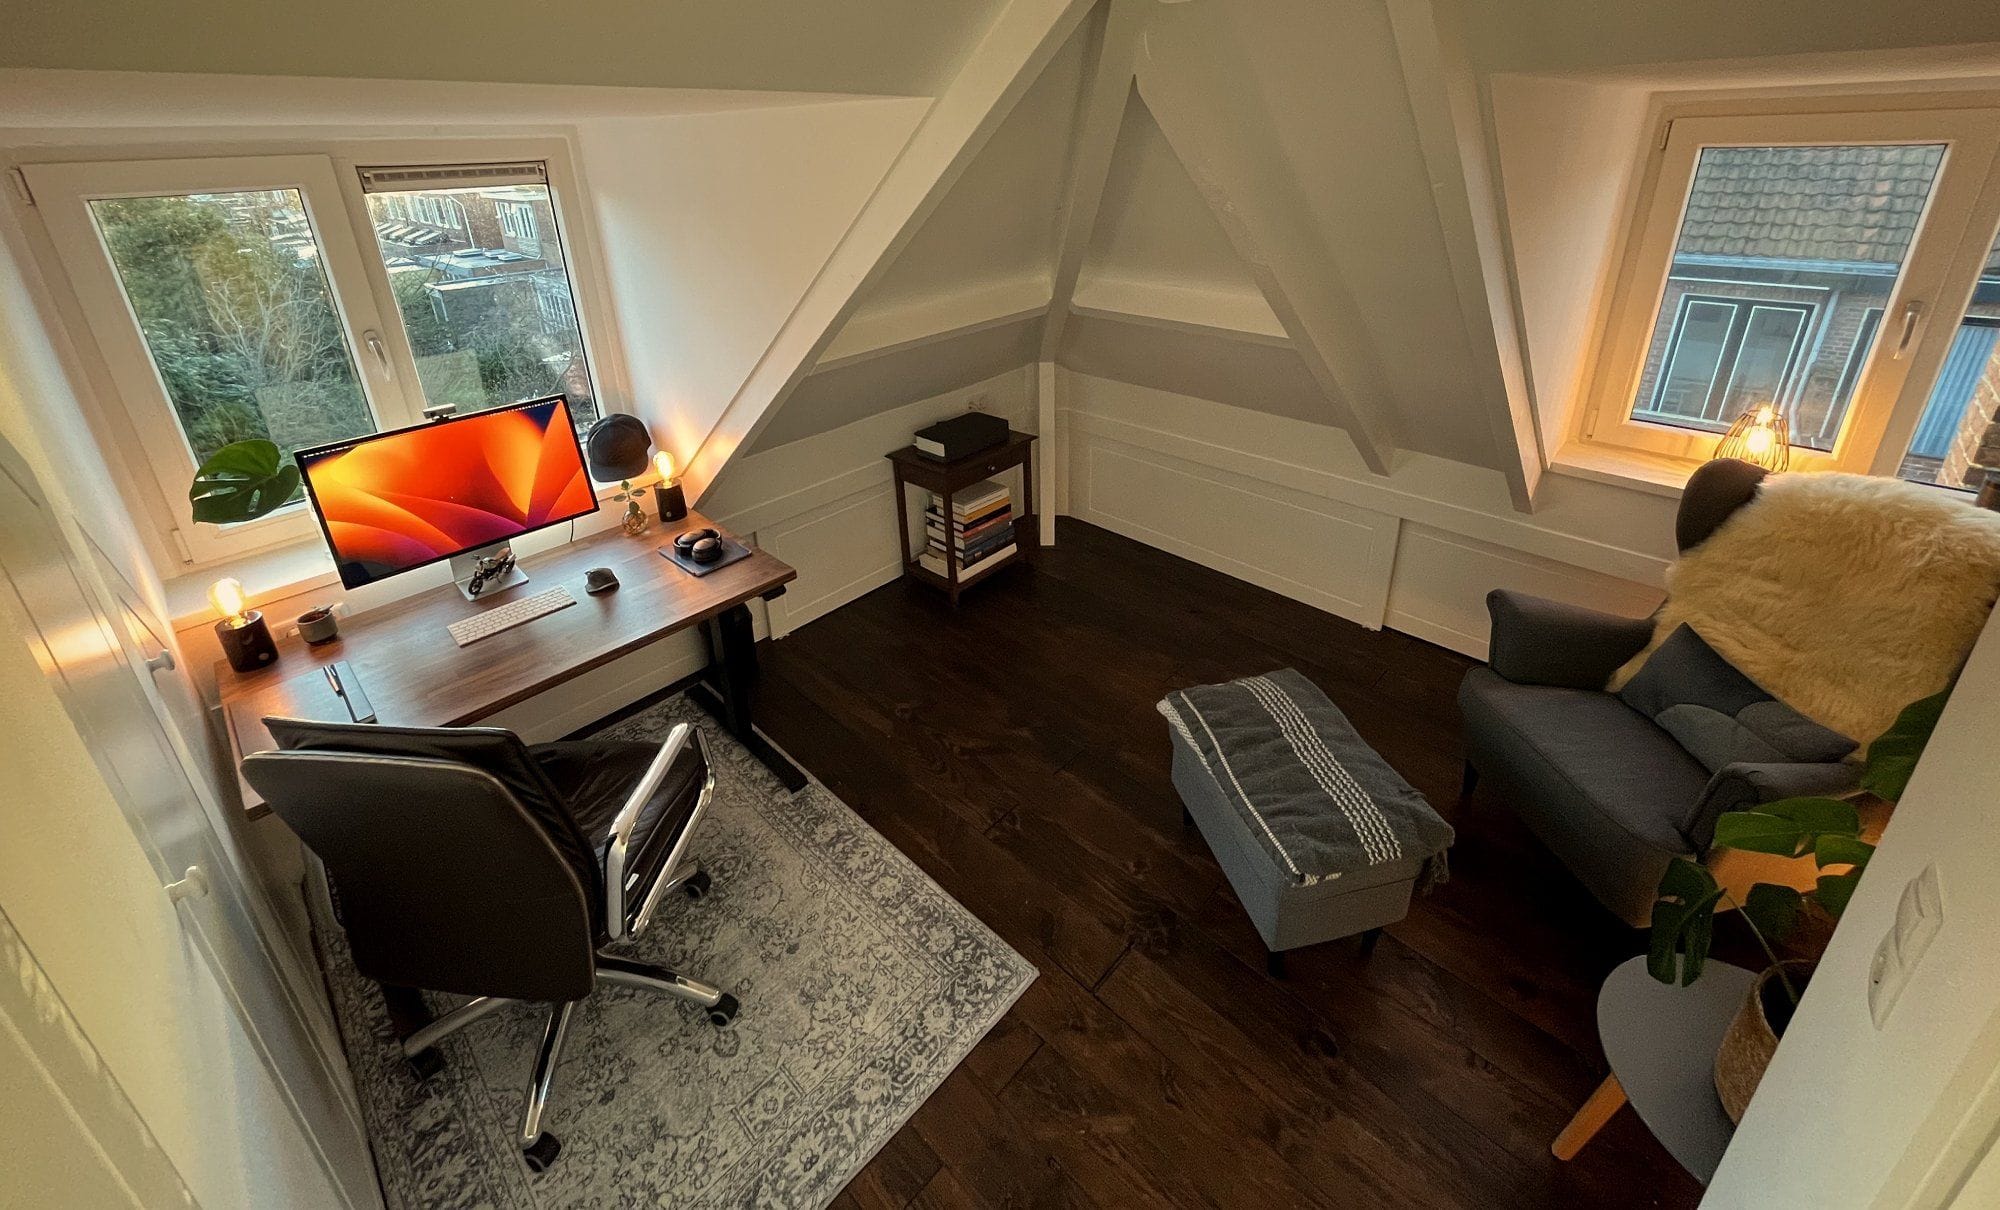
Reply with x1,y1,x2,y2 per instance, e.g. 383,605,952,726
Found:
1458,462,1856,926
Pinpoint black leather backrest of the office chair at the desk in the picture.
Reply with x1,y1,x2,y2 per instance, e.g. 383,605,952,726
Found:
244,718,602,1000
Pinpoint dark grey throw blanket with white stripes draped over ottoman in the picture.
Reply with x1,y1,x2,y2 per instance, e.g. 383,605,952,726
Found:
1158,668,1452,886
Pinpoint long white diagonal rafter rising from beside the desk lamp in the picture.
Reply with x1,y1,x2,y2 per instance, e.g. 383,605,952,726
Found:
684,0,1090,498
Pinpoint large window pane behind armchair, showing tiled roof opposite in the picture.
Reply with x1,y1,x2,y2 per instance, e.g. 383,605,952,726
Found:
1632,144,1944,450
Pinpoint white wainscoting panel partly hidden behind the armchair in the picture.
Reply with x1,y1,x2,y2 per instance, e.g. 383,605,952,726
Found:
1388,522,1662,660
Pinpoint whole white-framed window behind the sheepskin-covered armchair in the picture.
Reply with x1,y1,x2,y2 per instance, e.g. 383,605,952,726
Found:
1578,110,2000,486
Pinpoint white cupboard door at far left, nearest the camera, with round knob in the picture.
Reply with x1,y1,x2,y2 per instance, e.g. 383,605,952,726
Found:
0,442,380,1208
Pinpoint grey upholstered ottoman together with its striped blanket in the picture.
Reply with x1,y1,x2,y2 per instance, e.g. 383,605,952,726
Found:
1158,668,1452,976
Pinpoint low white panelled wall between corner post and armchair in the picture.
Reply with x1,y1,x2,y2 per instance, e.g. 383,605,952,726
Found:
1058,370,1674,656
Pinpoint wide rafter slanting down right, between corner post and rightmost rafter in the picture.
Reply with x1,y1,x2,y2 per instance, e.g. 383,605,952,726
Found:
1136,4,1398,474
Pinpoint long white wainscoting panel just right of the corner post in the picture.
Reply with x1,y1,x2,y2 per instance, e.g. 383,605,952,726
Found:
1070,432,1398,628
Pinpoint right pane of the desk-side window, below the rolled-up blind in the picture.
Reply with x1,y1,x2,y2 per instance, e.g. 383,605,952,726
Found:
368,184,598,422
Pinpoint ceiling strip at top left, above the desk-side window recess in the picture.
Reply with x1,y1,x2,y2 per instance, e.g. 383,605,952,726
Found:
0,0,1006,96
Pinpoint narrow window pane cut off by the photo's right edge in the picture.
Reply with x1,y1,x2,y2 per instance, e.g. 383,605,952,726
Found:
1898,226,2000,492
